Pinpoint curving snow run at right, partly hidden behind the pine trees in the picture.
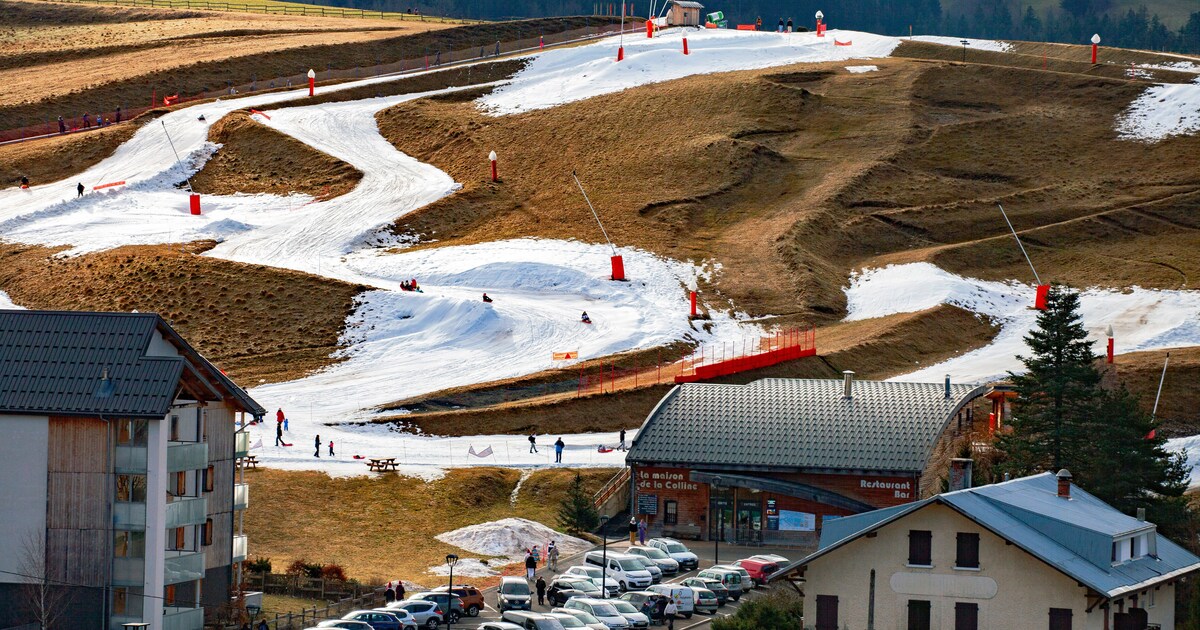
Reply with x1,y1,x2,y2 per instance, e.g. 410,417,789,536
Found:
846,263,1200,486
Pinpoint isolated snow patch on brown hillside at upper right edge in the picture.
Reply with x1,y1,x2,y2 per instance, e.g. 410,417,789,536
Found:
1116,79,1200,143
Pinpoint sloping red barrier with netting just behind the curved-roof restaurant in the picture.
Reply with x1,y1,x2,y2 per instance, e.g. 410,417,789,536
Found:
674,326,817,383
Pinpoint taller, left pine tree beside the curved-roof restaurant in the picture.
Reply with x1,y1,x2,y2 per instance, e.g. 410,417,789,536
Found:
998,284,1100,474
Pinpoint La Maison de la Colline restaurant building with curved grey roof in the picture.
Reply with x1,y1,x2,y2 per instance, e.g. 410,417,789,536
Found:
625,372,991,546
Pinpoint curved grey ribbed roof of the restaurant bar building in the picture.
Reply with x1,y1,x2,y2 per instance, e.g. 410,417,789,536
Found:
625,378,985,473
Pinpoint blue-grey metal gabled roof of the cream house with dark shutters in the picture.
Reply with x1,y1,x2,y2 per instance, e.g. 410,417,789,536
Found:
780,473,1200,598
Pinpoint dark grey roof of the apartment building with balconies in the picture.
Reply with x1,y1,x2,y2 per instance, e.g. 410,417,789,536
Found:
0,310,265,418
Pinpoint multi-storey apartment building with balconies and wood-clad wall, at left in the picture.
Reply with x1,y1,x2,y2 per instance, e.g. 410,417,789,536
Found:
0,311,265,630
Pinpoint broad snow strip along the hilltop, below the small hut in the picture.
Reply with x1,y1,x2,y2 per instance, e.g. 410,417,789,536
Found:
476,29,900,115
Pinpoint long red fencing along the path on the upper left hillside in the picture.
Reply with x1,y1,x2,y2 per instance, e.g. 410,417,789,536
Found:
0,24,636,143
